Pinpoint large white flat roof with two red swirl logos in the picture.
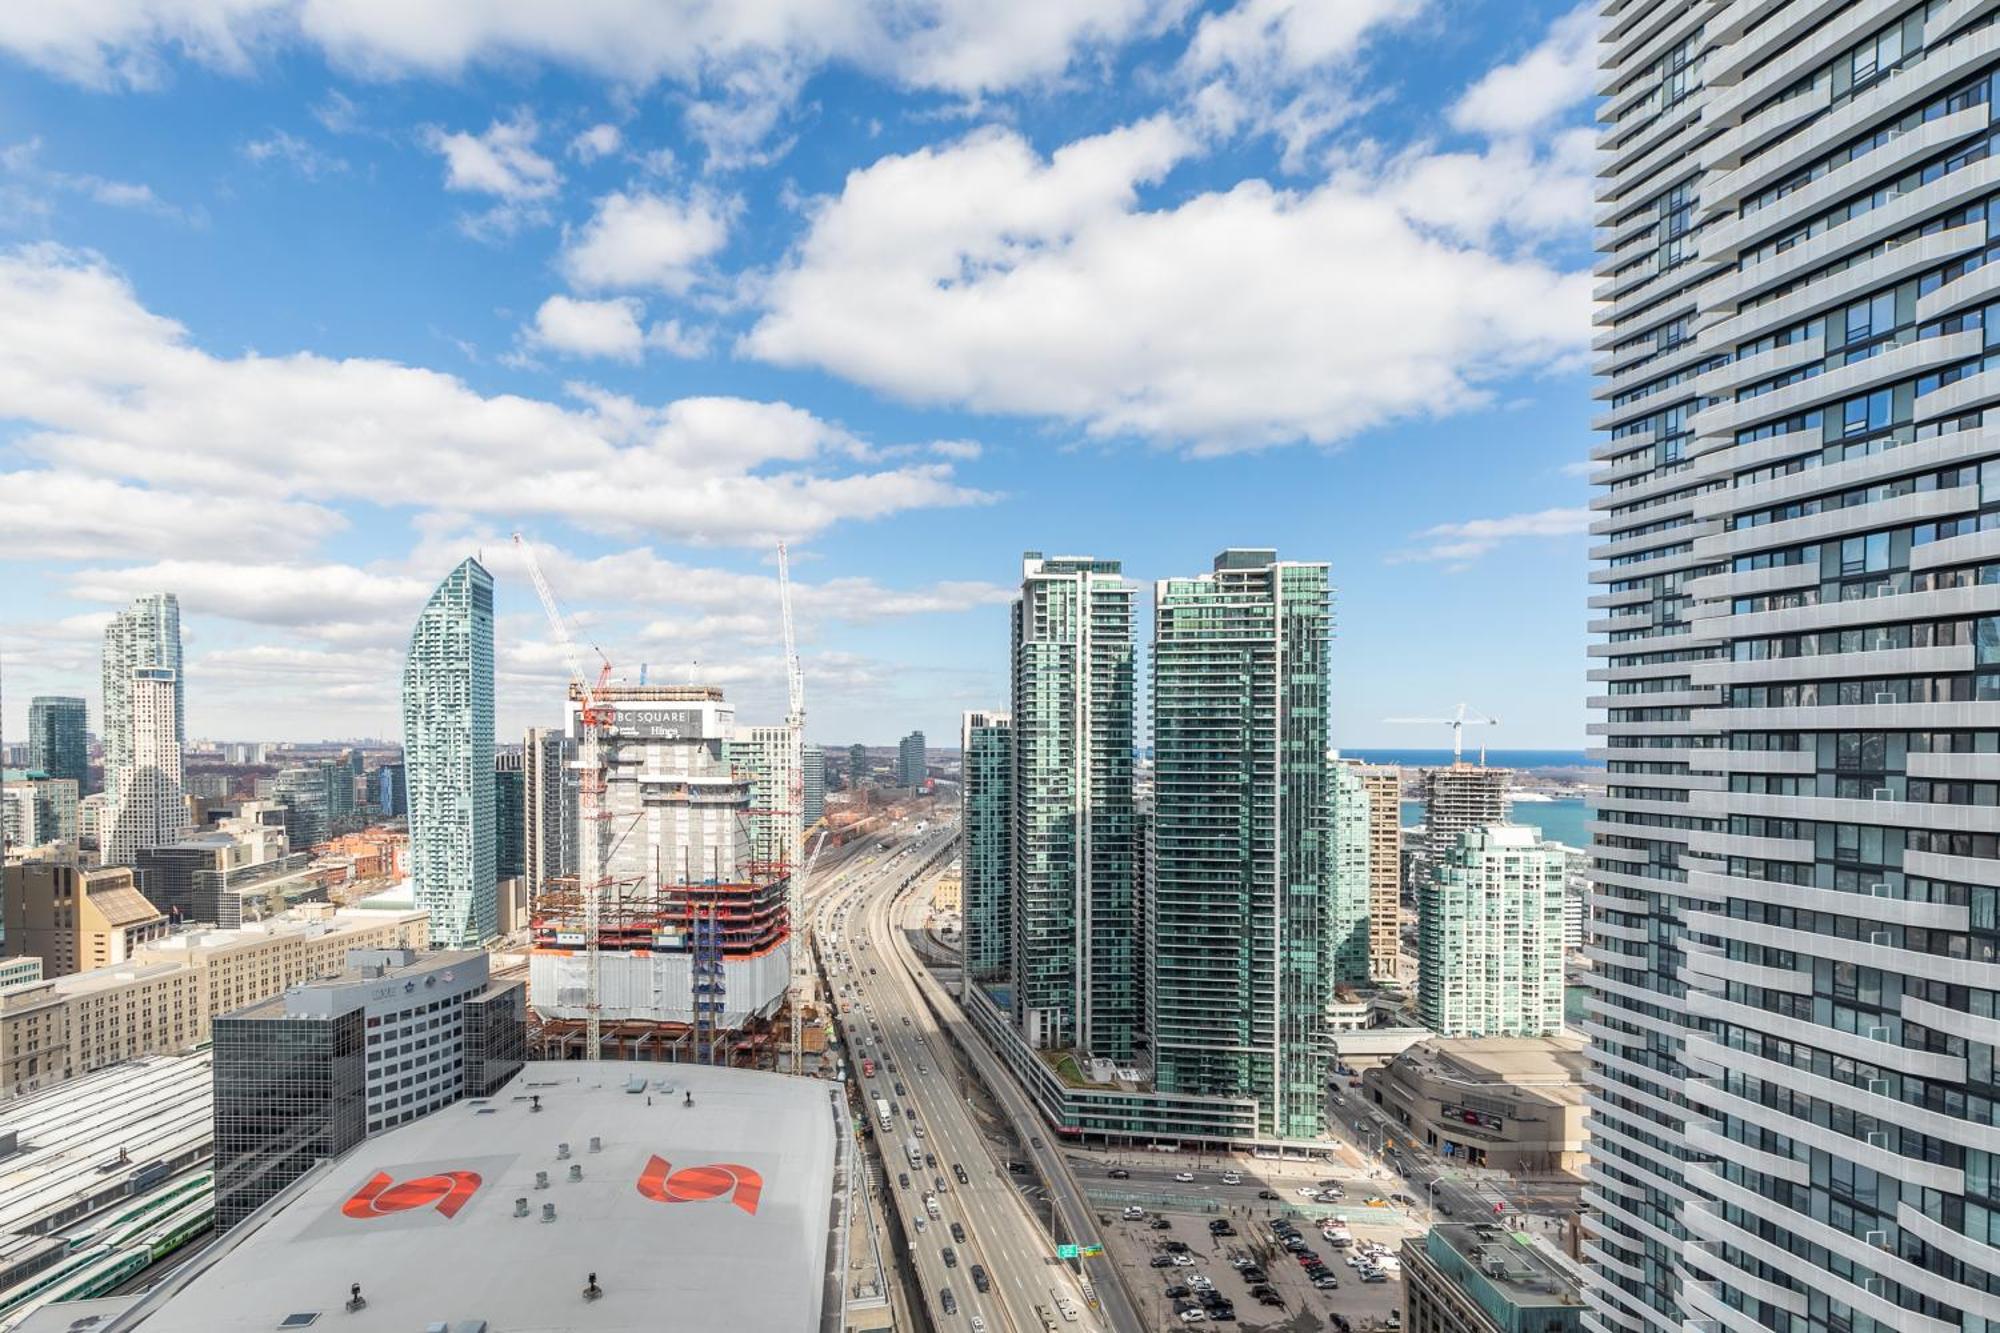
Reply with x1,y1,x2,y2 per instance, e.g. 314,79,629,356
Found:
84,1061,846,1333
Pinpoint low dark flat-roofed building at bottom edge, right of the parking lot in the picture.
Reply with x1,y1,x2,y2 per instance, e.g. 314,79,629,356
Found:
1402,1223,1584,1333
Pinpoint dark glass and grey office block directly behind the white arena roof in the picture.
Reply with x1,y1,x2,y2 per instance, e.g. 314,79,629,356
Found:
212,949,528,1231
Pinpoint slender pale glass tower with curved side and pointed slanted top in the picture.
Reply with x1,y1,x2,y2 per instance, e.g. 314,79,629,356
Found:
402,558,500,949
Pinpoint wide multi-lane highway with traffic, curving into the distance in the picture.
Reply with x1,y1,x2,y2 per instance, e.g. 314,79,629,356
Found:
808,827,1102,1333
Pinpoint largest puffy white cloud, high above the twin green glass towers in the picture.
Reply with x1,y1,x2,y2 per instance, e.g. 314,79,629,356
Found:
740,118,1590,452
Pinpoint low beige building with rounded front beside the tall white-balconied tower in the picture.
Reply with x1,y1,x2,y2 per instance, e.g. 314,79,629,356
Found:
1362,1037,1588,1175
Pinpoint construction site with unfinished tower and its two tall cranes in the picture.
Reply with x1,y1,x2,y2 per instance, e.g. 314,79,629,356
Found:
528,536,822,1071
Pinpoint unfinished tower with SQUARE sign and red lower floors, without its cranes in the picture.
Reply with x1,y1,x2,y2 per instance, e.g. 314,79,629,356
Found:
528,685,792,1065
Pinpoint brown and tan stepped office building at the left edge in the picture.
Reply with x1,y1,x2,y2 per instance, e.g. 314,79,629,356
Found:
0,861,166,977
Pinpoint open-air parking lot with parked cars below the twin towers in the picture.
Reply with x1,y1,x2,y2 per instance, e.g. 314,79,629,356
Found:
1106,1209,1402,1333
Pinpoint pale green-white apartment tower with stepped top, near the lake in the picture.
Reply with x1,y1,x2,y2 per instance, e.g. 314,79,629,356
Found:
1416,825,1564,1037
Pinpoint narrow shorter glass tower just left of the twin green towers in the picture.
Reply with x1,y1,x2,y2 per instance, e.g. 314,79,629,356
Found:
958,711,1014,983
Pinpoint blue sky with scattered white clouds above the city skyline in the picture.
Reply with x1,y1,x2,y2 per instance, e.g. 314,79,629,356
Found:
0,0,1594,749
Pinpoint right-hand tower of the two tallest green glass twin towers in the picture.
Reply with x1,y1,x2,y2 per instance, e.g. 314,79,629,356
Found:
1160,550,1332,1137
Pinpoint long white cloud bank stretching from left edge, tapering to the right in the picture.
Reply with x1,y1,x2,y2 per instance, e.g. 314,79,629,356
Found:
0,246,988,544
